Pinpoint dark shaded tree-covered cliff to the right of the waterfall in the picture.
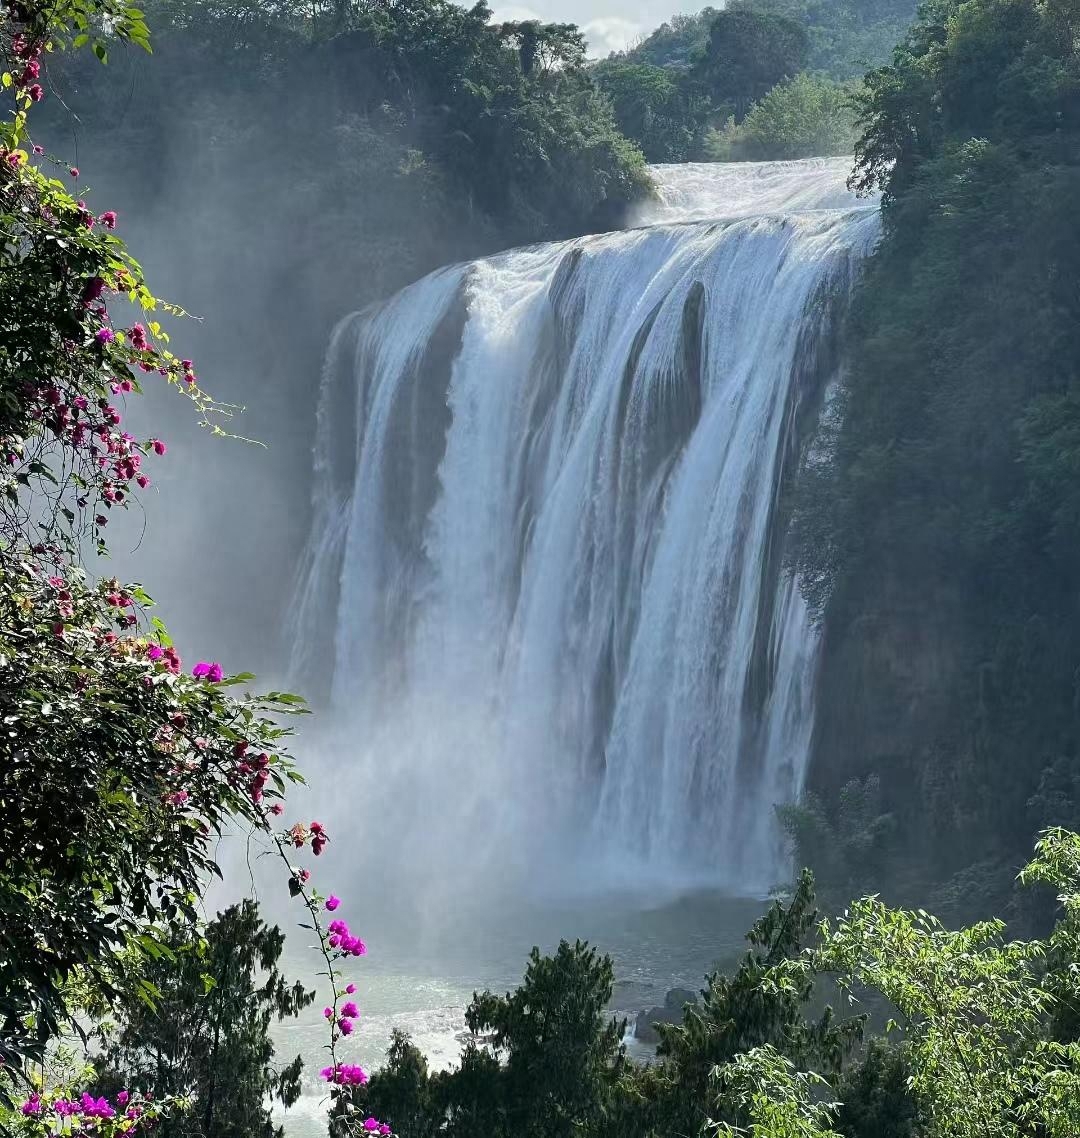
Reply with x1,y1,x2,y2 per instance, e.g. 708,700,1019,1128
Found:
787,0,1080,912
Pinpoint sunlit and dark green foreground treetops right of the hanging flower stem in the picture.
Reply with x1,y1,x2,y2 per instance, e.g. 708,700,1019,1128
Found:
332,831,1080,1138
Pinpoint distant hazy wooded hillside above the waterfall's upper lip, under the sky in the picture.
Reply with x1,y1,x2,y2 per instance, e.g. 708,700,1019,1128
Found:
593,0,915,162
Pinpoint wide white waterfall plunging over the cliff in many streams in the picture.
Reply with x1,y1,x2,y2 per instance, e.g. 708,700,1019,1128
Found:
292,159,879,892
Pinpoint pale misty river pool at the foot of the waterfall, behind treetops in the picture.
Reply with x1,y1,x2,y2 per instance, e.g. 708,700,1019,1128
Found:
274,892,765,1138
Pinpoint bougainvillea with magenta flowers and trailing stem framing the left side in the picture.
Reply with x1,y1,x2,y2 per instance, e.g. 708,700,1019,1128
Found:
0,0,390,1138
